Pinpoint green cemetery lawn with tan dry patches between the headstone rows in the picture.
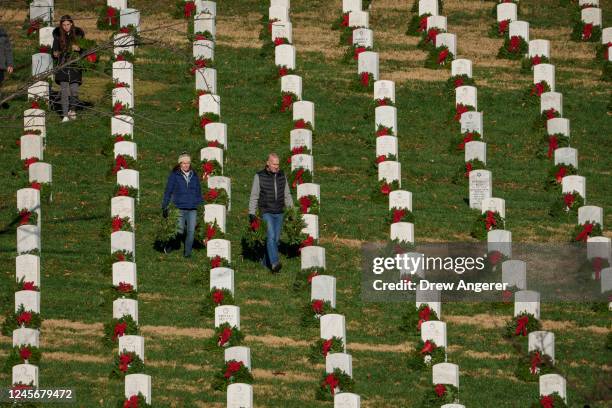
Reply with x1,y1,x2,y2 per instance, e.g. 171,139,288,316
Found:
0,0,612,407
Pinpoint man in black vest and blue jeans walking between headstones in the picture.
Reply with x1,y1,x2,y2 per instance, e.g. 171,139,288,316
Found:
249,153,293,272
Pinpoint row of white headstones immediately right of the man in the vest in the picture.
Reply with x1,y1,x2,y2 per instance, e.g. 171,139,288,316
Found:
268,0,360,408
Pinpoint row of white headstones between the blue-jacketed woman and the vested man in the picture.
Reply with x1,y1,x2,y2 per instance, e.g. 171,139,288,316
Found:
186,1,253,408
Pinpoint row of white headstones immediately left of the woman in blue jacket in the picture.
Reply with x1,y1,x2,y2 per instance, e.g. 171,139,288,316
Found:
107,7,152,404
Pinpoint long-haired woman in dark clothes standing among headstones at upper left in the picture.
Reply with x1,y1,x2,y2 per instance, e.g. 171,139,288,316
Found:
52,15,85,122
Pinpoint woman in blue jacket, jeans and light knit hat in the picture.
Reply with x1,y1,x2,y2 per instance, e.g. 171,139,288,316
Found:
162,152,204,258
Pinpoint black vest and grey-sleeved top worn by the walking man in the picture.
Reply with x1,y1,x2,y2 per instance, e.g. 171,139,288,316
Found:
249,168,293,215
